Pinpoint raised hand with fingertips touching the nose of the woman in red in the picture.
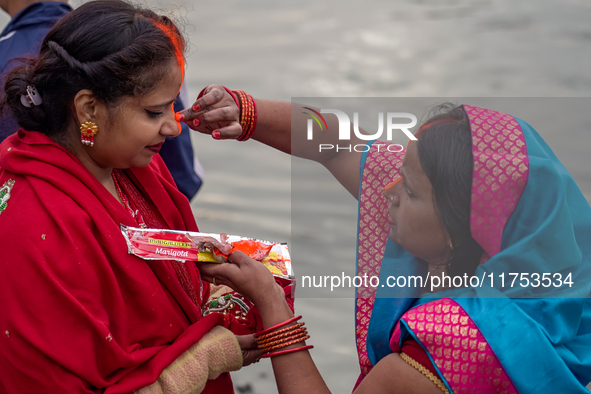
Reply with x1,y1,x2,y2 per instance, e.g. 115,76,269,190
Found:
177,85,242,140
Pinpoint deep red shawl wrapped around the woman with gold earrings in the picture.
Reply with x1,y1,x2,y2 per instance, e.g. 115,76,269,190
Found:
0,130,233,394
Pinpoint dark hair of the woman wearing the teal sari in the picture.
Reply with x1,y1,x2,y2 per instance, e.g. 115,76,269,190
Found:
417,103,483,276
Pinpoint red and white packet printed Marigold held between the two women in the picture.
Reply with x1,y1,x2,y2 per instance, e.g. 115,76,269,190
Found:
121,225,295,281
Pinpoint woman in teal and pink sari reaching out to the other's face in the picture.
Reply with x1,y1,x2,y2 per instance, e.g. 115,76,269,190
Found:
184,93,591,393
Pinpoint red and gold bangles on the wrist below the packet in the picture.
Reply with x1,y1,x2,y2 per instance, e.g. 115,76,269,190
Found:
254,316,314,358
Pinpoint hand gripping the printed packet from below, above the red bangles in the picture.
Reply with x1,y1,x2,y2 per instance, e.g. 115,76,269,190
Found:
196,252,285,309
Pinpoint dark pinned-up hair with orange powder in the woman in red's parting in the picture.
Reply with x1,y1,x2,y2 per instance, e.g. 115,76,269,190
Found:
0,0,185,136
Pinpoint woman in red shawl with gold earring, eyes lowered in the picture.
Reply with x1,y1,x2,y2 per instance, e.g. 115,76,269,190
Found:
0,0,266,393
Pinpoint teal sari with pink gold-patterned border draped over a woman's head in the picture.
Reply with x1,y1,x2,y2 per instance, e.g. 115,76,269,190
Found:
357,105,591,393
